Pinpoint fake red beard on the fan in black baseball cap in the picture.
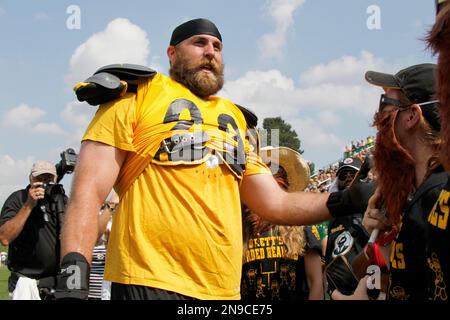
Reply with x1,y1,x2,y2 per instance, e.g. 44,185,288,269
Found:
374,110,415,225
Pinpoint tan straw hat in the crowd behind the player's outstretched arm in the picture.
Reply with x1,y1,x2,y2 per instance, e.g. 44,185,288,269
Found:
261,146,310,192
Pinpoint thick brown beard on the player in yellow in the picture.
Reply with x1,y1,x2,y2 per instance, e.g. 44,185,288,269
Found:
169,54,224,99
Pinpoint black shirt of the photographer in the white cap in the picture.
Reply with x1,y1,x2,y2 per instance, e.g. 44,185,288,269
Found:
0,186,67,279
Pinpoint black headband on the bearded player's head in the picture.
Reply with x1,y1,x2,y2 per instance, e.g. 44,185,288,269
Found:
170,19,222,46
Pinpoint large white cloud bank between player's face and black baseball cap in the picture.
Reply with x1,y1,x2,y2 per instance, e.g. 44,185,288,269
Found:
221,52,386,163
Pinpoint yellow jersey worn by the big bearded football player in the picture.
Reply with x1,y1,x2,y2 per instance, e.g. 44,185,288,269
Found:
83,74,271,299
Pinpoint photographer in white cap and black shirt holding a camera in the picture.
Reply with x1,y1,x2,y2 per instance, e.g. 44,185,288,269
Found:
0,161,67,300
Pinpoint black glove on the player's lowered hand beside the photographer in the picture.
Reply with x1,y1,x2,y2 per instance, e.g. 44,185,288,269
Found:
55,252,90,300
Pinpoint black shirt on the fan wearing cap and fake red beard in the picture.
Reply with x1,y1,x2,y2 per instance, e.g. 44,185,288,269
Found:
388,167,447,300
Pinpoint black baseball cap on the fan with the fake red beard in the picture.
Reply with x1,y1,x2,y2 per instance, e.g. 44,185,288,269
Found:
365,63,441,131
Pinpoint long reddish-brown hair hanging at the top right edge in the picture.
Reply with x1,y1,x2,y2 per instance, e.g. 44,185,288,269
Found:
427,3,450,171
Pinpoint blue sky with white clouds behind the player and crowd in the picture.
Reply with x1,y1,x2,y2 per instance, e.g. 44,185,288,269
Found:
0,0,435,204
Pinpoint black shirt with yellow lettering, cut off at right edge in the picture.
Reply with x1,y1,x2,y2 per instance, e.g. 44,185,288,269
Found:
427,177,450,301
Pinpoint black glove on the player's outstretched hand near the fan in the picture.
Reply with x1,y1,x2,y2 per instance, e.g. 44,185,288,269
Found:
327,156,376,217
